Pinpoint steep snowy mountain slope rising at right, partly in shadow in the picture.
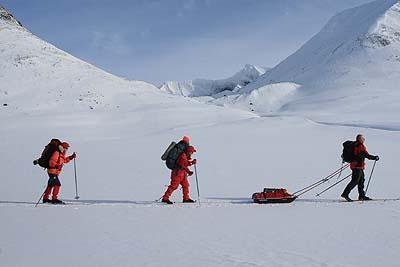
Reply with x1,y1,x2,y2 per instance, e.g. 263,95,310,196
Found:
236,0,400,127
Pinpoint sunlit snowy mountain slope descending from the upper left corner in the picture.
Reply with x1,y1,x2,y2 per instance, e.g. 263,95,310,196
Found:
0,3,254,131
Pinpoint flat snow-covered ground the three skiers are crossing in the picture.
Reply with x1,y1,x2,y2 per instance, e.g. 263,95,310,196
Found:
0,110,400,266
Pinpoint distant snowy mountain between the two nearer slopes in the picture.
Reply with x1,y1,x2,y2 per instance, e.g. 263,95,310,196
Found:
160,64,267,97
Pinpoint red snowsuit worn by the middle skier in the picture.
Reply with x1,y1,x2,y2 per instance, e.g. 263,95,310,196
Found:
162,153,193,200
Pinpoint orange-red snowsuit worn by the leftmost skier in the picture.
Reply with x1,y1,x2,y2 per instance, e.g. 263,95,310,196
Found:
43,151,72,200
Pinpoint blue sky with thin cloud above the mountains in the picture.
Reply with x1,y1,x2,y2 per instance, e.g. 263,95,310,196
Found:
0,0,370,84
